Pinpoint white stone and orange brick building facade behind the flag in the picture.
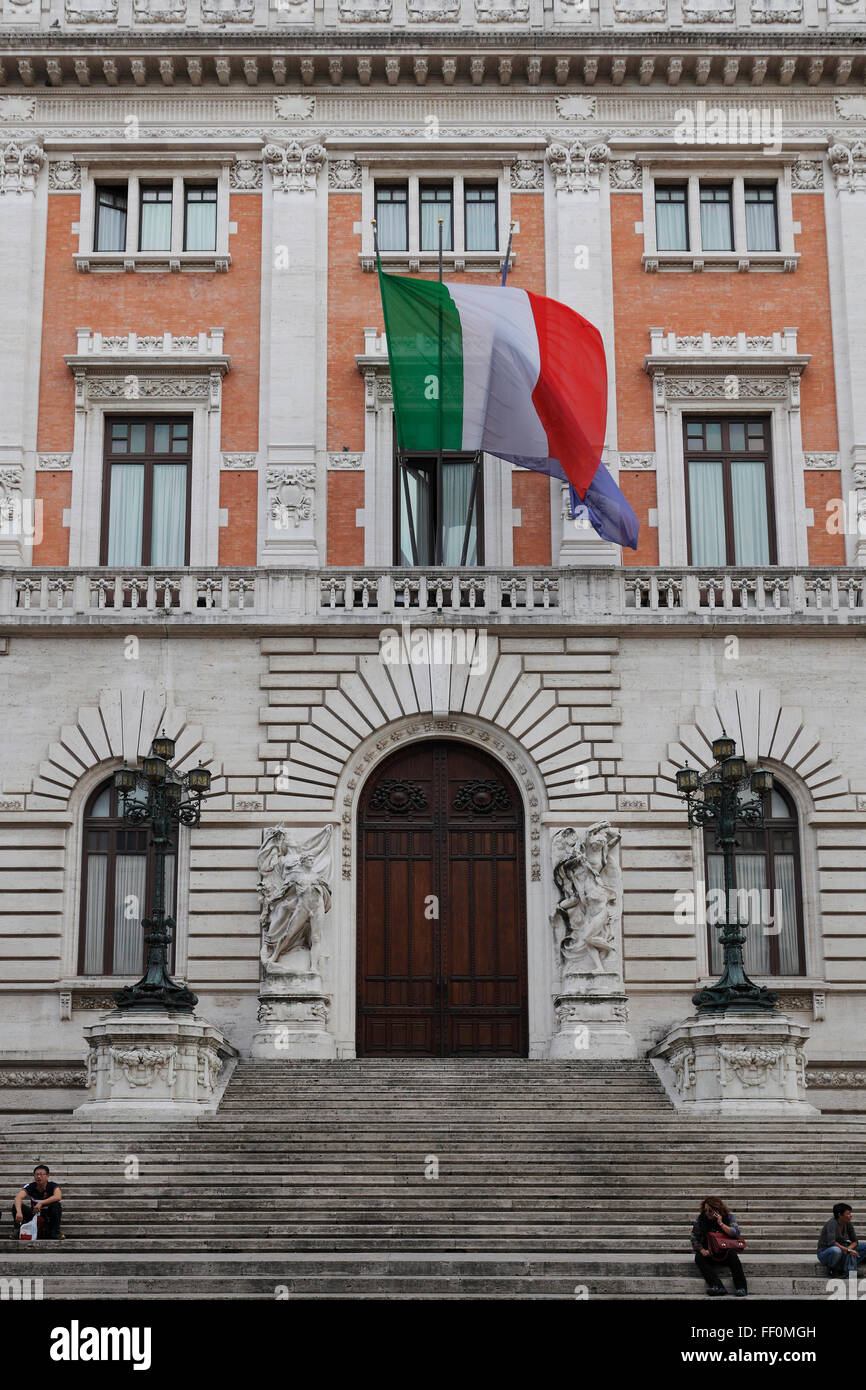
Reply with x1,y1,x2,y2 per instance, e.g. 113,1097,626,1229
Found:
0,0,866,1106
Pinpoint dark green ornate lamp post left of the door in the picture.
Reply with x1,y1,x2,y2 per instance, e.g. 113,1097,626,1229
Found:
114,734,210,1013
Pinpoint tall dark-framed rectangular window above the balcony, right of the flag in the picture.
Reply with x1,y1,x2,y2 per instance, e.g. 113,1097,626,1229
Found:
683,416,776,567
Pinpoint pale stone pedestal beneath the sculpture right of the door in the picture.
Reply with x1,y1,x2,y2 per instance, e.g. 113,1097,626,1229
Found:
550,974,638,1062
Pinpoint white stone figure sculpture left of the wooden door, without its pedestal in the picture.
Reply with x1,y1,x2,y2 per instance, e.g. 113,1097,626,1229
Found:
257,824,331,979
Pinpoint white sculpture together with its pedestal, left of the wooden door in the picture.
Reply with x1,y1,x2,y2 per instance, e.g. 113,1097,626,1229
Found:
252,824,334,1058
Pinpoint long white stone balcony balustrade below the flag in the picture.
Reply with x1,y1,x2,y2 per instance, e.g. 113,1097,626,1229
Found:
0,567,866,632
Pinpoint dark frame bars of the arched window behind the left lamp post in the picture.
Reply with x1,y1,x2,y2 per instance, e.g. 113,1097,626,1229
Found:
76,778,181,980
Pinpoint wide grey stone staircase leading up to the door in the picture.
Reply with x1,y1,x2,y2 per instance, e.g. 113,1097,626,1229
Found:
0,1059,866,1300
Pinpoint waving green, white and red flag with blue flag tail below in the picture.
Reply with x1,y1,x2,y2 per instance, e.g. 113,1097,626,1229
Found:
379,271,638,548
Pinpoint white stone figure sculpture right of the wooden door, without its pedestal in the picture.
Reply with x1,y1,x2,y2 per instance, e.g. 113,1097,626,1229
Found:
552,820,623,979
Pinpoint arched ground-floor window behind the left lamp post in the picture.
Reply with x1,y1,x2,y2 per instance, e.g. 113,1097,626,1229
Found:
78,783,177,976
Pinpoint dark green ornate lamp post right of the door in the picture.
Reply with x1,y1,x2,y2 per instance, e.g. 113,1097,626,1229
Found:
677,734,778,1013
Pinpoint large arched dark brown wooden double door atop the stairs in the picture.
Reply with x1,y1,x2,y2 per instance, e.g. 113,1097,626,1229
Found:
357,739,528,1056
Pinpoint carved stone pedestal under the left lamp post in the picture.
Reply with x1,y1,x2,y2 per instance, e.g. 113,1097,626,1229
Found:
75,1009,238,1119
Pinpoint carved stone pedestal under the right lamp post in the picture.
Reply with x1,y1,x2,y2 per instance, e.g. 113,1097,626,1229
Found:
651,1011,820,1115
